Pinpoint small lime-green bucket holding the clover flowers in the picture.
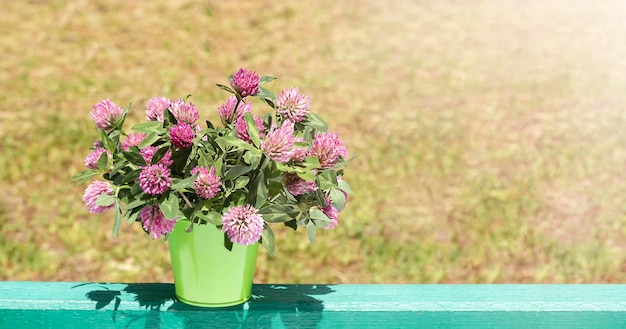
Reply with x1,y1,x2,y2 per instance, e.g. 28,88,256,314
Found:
168,220,259,307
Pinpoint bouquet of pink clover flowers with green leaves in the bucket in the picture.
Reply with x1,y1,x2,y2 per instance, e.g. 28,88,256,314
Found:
72,68,352,254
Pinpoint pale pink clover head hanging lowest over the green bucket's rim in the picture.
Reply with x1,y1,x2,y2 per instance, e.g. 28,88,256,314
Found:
222,205,264,246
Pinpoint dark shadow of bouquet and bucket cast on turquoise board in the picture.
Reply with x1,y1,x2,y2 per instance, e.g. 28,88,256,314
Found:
79,283,333,328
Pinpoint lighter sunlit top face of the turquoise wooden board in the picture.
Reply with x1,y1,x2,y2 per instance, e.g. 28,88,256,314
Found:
0,281,626,312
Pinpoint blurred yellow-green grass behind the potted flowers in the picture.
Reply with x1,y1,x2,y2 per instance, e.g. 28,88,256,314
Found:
0,0,626,283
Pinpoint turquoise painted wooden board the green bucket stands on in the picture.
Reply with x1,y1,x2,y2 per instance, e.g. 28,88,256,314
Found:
0,282,626,329
